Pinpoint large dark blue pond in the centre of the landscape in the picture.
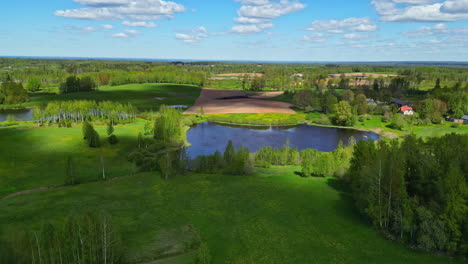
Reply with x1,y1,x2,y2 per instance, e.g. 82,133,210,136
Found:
187,123,379,158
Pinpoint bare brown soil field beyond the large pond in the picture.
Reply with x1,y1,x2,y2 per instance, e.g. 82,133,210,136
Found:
185,88,296,115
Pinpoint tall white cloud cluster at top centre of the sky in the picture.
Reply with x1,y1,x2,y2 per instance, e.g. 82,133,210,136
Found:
231,0,306,35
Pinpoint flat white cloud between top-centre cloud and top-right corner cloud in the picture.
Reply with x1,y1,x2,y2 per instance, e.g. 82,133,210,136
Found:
307,17,377,34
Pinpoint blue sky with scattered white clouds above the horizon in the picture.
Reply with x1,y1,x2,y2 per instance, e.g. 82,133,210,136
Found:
0,0,468,61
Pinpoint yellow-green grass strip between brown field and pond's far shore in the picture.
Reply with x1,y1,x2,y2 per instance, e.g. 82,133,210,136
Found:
205,113,305,126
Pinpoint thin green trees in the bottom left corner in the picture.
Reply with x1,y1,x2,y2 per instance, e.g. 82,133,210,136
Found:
0,212,124,264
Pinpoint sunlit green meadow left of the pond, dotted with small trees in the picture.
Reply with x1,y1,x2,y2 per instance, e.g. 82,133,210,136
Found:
0,121,144,197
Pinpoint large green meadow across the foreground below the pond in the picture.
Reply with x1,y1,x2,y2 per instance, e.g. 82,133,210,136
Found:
0,167,462,264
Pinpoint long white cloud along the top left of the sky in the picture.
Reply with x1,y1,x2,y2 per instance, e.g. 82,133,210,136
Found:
55,0,186,20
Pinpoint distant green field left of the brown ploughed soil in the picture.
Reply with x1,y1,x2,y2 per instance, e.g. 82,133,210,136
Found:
0,84,201,110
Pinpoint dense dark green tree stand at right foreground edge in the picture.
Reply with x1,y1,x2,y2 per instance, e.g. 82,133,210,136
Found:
347,134,468,256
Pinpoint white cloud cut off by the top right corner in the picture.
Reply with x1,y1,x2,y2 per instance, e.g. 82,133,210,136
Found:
371,0,468,22
